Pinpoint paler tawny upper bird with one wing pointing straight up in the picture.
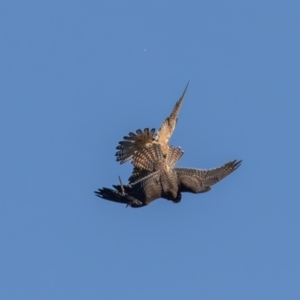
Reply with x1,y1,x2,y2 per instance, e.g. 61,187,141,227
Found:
116,83,189,164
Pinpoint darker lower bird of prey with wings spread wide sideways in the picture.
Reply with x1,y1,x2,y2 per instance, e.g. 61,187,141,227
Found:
95,143,241,207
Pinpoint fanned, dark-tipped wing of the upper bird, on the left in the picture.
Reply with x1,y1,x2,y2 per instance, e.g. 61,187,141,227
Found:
116,128,155,164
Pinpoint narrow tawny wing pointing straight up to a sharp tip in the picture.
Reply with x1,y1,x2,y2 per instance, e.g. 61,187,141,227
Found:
156,83,189,155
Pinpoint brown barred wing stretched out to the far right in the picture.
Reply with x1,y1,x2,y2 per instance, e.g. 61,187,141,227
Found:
175,160,242,193
